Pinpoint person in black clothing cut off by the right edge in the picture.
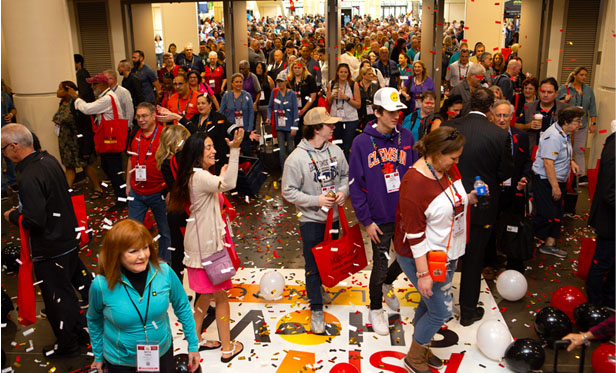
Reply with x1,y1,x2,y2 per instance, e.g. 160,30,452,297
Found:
586,129,616,307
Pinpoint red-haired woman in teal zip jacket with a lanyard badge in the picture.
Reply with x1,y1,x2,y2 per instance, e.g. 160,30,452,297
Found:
87,219,200,373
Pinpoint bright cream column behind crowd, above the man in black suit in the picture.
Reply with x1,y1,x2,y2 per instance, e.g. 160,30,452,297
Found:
464,1,505,53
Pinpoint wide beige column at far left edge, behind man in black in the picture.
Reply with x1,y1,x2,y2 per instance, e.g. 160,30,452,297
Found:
2,0,76,160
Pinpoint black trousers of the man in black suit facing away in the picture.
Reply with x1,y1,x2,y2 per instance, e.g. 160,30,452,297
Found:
460,224,492,318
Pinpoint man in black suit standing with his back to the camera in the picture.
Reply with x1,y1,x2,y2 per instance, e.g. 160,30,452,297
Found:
444,88,513,326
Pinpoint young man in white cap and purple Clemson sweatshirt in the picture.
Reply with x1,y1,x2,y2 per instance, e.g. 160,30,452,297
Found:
349,88,418,335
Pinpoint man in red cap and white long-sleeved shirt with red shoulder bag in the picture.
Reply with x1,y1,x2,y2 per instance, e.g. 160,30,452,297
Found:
69,74,126,211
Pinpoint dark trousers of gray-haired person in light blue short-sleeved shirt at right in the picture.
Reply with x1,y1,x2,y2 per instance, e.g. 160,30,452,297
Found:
533,175,566,240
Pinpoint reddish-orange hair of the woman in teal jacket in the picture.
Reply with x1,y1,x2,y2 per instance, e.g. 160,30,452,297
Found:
98,219,160,290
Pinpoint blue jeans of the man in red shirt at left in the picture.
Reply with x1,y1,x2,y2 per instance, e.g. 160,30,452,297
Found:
128,189,171,263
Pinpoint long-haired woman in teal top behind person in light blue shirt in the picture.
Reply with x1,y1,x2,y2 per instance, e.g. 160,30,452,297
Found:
556,66,597,177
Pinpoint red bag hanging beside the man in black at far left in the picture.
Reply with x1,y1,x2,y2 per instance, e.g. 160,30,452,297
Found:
17,215,36,325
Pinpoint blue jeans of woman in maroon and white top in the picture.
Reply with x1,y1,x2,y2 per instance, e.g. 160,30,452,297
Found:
396,254,457,345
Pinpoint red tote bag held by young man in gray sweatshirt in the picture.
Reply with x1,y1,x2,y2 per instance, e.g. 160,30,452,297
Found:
312,206,368,287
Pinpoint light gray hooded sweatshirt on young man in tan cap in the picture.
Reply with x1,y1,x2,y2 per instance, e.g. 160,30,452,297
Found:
282,139,349,223
